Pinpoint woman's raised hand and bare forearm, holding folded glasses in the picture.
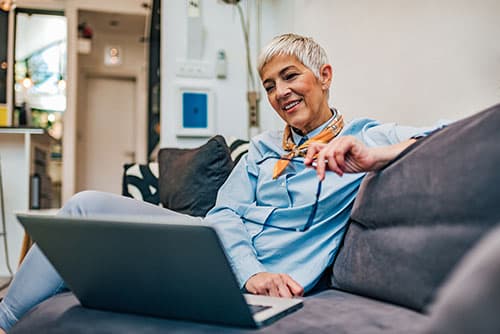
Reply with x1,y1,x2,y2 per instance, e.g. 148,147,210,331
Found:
304,136,415,180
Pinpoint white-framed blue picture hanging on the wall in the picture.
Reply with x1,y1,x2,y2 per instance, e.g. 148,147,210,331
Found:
176,86,214,137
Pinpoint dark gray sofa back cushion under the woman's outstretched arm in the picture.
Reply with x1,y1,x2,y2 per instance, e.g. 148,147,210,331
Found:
332,105,500,310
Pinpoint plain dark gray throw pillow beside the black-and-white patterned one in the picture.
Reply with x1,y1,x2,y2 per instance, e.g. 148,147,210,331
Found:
158,135,233,217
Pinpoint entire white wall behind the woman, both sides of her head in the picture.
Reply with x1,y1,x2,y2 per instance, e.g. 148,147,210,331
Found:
161,0,500,146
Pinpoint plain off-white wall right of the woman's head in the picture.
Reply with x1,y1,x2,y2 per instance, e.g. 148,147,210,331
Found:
270,0,500,125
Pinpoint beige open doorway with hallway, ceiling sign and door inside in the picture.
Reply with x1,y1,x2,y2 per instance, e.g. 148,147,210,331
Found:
72,10,147,194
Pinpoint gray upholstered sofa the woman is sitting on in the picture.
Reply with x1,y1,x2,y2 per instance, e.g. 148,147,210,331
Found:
11,105,500,334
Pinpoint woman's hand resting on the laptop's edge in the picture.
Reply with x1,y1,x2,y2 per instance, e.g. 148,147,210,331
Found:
245,272,304,298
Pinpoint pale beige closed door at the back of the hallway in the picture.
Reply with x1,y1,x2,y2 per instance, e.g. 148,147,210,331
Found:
76,77,136,194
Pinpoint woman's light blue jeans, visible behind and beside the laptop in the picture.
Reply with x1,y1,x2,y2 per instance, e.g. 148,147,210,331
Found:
0,191,200,331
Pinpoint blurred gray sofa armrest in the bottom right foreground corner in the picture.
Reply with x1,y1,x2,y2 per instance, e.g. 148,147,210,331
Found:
424,227,500,334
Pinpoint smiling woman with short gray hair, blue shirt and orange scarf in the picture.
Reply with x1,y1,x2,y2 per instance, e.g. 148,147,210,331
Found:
0,34,432,333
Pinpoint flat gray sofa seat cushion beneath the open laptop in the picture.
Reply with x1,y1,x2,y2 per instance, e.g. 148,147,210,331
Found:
9,290,426,334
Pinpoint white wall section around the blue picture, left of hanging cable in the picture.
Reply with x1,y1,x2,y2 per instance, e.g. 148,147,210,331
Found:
161,0,247,147
